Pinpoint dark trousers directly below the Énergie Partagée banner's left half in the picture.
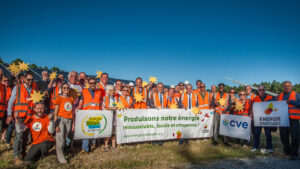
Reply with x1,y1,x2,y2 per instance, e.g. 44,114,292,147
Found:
253,127,273,149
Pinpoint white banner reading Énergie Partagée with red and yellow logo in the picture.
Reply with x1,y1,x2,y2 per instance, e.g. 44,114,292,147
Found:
253,101,290,127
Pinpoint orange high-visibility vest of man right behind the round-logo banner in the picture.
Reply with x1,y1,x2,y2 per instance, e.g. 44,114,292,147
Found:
82,89,102,110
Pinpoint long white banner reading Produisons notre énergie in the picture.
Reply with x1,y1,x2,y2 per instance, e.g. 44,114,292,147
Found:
117,109,213,144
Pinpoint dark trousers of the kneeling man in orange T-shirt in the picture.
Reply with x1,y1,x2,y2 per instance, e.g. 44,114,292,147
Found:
24,140,54,161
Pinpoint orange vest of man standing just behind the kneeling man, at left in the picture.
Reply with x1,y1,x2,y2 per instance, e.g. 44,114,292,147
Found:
14,84,36,118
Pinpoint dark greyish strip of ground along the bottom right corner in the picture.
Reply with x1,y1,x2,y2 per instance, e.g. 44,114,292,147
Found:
185,156,300,169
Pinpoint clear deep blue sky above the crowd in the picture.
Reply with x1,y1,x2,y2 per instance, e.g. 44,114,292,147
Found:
0,0,300,85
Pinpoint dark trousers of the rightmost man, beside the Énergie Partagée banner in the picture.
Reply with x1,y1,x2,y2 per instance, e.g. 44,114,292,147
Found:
279,119,299,156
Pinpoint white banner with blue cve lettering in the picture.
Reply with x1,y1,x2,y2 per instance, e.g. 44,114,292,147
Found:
220,114,251,140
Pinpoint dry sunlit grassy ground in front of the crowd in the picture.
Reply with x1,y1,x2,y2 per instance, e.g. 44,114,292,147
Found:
0,132,282,169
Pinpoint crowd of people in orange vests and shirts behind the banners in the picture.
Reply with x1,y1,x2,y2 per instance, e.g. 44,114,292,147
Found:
0,69,300,164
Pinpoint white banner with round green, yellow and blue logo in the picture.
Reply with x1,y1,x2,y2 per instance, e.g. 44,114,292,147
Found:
74,110,113,139
